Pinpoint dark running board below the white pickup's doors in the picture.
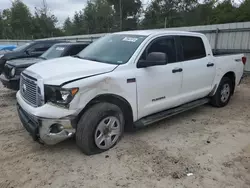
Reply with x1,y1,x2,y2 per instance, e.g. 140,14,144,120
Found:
134,98,210,128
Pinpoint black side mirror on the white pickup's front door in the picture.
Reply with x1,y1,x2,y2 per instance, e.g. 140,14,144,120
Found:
137,52,168,68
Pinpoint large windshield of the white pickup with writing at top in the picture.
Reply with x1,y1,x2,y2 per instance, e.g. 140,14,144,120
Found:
78,34,146,65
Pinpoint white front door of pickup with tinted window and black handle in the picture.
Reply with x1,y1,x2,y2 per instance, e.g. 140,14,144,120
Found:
136,36,183,119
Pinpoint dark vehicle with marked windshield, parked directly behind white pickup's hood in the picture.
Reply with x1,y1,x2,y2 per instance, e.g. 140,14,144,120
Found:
0,42,89,90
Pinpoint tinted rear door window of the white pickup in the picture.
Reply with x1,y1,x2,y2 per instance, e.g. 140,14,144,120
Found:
180,36,206,61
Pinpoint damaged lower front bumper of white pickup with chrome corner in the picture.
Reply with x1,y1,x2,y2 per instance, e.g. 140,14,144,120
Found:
17,103,75,145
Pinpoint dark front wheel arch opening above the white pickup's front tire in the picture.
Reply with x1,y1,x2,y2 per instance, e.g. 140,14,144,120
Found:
77,94,134,130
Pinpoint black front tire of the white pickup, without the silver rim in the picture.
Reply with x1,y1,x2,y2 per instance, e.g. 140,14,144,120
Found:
76,102,124,155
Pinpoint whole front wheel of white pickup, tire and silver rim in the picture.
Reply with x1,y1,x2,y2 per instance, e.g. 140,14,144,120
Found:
76,103,124,155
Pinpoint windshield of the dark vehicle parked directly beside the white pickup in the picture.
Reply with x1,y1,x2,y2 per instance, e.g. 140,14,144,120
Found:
40,44,68,59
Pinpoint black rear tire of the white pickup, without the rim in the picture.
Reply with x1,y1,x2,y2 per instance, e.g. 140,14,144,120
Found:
211,77,233,108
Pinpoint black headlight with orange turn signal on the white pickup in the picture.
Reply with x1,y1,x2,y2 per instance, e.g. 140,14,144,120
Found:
44,85,79,107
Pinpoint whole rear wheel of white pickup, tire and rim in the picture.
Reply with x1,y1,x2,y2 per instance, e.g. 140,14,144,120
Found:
211,77,233,107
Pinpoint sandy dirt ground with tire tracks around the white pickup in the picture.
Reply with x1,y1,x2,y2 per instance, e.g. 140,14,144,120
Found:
0,78,250,188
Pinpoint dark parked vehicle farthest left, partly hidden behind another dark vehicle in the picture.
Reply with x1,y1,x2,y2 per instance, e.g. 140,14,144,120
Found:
0,40,63,74
